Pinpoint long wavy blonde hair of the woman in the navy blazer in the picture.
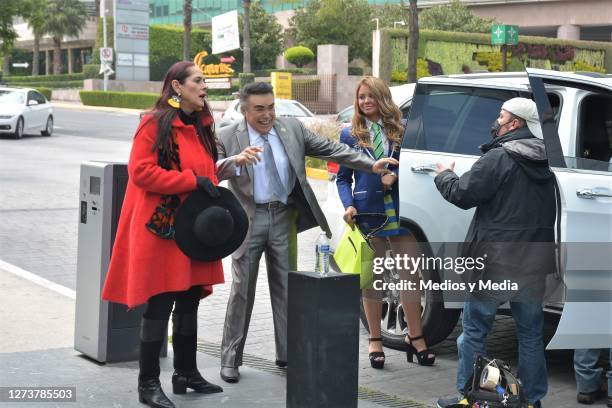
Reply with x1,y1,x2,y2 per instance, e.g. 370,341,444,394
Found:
351,76,404,149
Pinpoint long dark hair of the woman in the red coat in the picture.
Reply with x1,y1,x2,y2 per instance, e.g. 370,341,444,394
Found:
149,61,219,163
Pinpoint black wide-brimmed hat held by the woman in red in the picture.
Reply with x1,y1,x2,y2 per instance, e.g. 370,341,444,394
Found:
174,186,249,262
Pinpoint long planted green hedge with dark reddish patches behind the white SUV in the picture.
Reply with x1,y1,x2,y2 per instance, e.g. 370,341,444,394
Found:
380,28,612,81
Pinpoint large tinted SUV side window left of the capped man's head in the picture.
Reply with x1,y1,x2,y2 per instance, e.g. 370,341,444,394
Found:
404,85,518,155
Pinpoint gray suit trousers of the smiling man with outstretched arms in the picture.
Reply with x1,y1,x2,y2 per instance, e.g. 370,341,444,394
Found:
221,206,294,367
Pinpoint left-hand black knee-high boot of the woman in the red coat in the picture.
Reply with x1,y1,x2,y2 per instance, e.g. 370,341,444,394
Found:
138,317,175,408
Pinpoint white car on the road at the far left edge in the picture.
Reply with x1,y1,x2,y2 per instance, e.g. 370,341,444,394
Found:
0,88,53,139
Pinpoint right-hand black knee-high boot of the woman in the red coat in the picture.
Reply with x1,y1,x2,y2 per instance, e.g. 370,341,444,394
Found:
172,312,223,394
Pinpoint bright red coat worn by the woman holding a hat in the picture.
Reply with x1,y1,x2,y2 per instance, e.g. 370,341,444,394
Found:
102,115,224,307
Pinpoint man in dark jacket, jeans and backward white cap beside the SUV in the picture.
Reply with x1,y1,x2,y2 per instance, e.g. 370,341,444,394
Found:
435,98,556,407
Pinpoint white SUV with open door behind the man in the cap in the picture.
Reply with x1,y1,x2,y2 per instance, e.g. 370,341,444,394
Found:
326,69,612,349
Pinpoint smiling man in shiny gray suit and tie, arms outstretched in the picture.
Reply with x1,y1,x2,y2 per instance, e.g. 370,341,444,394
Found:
218,82,397,382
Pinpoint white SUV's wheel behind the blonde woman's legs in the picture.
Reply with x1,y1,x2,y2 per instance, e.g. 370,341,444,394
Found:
354,239,461,350
